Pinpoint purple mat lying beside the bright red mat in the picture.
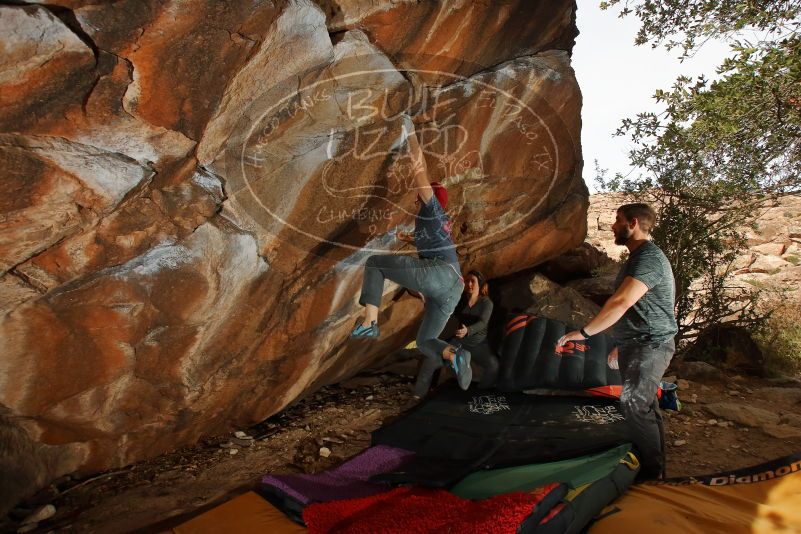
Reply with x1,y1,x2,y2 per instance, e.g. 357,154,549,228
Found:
261,445,414,505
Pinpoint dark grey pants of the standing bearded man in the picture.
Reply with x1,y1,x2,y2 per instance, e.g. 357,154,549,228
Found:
618,339,676,478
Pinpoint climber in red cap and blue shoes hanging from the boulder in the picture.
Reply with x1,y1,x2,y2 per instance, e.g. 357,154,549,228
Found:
351,125,473,399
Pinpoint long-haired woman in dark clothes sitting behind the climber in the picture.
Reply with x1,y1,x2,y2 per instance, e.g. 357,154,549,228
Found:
446,270,499,388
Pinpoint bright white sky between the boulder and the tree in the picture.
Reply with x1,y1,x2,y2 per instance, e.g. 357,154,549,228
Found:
573,0,729,191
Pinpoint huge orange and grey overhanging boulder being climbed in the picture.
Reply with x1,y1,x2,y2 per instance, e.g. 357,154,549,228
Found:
0,0,587,508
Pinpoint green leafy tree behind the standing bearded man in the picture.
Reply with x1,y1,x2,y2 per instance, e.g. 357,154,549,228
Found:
598,0,801,339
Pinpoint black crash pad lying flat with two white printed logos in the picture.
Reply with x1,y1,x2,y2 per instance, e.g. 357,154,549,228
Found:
373,384,629,487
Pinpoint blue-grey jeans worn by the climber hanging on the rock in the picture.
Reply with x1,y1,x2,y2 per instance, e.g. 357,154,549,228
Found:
359,254,464,397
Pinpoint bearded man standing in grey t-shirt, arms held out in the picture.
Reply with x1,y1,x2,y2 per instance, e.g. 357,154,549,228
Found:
558,203,678,478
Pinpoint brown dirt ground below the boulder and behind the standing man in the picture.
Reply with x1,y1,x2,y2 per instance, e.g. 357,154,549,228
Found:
0,362,801,533
